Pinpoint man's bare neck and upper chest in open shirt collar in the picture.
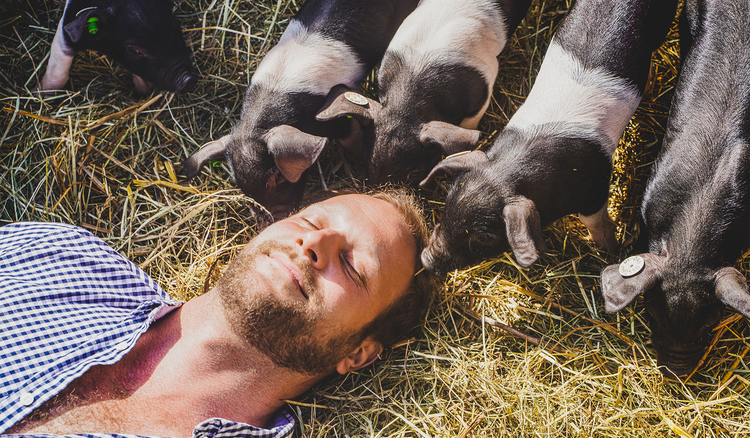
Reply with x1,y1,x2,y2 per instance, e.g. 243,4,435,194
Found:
8,292,319,436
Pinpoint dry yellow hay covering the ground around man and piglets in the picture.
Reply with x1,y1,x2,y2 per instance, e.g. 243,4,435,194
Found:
0,0,750,437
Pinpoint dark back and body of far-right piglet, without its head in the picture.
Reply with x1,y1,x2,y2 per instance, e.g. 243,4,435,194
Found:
643,0,750,264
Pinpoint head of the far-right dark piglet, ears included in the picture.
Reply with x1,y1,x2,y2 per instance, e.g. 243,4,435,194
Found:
601,253,750,376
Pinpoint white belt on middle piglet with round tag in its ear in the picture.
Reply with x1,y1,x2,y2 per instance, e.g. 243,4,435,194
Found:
378,0,506,129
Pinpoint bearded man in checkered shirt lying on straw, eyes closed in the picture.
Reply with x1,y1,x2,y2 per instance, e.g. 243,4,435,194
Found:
0,189,430,437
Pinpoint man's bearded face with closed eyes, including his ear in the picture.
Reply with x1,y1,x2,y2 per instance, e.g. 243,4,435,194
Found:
217,195,417,376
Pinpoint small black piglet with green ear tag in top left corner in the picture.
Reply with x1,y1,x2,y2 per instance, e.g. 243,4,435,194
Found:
39,0,198,94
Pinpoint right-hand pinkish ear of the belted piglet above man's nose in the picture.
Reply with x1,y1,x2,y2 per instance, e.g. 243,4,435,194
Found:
265,125,326,183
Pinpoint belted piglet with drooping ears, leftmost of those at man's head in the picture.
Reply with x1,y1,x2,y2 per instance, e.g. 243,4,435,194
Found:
183,0,417,218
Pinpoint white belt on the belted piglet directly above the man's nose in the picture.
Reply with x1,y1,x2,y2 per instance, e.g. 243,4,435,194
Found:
252,20,366,94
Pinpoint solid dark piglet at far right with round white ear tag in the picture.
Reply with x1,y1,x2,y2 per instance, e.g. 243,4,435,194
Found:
602,0,750,376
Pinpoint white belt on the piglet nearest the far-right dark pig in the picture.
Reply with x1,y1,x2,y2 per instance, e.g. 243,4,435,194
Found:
506,39,641,155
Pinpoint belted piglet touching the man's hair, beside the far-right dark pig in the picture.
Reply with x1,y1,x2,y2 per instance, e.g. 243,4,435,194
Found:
422,0,676,274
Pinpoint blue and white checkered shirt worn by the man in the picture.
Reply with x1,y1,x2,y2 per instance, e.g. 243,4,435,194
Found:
0,223,294,438
